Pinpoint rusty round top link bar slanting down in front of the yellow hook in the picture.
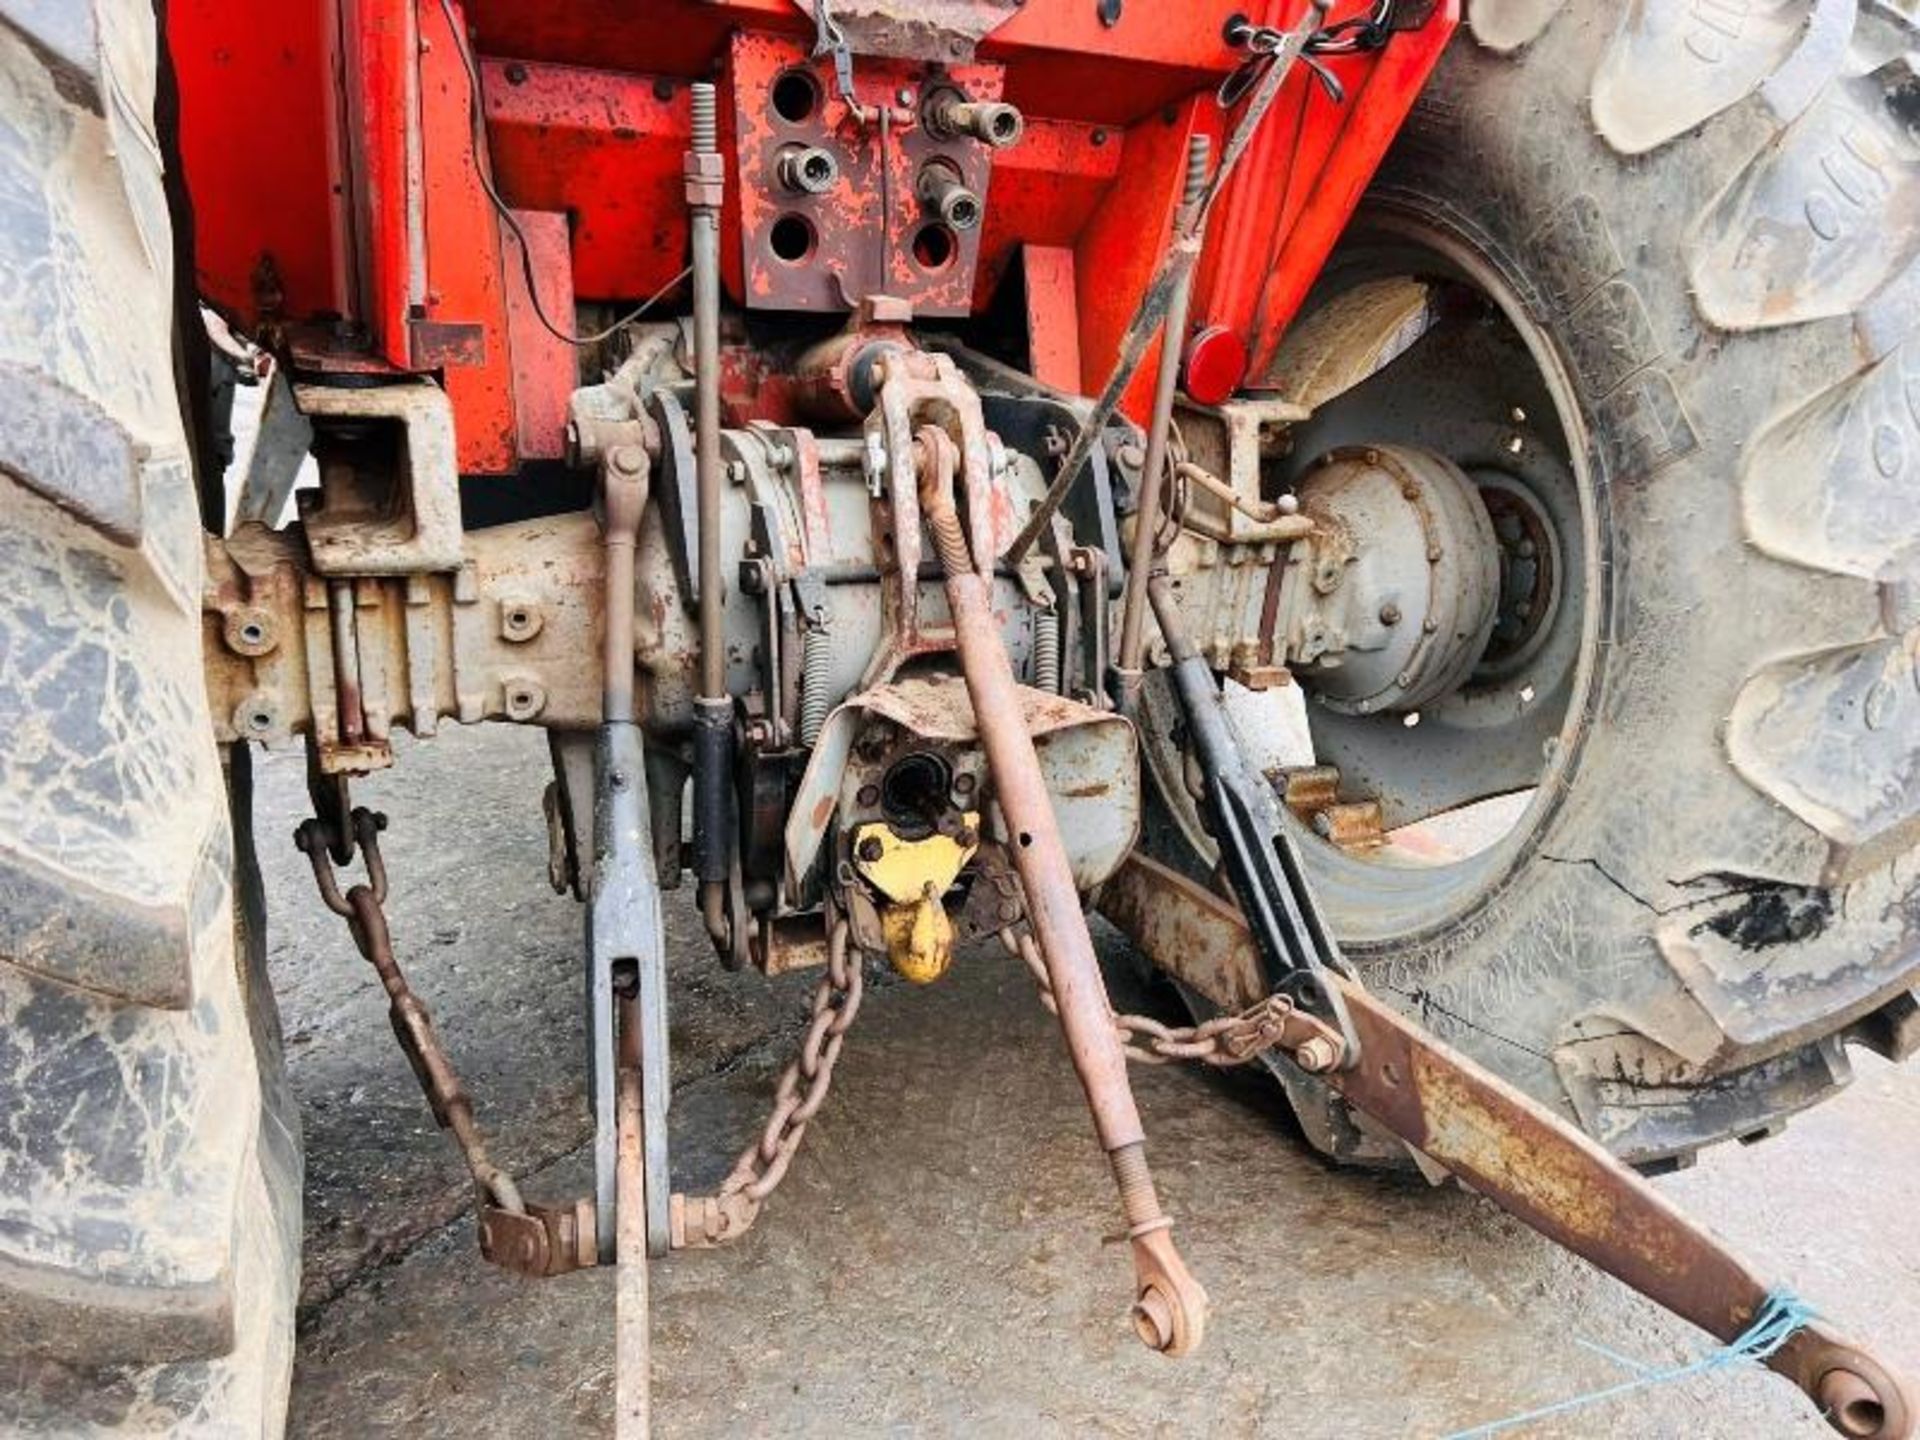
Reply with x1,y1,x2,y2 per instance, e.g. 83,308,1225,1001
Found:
914,424,1208,1356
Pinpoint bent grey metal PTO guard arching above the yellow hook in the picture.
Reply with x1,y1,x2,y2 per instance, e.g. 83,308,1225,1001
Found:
785,676,1140,899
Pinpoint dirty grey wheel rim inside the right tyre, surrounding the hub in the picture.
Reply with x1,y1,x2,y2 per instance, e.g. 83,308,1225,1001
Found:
1144,211,1607,952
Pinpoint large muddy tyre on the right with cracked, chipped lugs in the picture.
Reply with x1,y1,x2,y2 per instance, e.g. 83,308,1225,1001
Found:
1154,0,1920,1164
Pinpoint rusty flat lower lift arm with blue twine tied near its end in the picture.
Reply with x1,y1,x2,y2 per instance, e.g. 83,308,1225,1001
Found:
1100,854,1916,1440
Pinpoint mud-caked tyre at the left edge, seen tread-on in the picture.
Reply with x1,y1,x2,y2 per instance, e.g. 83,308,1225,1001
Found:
0,2,300,1436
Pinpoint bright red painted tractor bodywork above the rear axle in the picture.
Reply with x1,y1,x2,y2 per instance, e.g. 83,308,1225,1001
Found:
167,0,1459,474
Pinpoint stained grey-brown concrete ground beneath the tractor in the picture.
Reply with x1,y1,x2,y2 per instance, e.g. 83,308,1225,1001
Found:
259,730,1920,1440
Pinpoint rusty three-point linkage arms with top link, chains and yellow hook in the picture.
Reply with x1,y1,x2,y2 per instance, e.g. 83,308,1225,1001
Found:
296,355,1912,1440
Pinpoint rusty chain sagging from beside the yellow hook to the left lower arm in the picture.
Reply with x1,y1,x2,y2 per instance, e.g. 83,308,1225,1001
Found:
670,916,866,1250
